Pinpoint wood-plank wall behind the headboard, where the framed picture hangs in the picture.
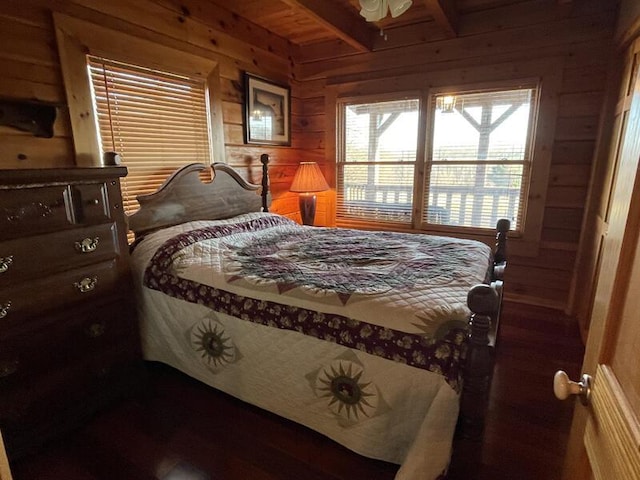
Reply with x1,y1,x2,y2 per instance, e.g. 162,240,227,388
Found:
0,0,318,223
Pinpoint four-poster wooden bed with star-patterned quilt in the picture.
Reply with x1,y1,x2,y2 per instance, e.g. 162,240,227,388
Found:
129,155,509,480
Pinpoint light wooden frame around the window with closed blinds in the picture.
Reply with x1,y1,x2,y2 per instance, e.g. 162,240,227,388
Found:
54,12,225,167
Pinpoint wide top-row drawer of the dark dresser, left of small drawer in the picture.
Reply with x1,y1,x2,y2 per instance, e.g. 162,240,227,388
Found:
0,185,74,240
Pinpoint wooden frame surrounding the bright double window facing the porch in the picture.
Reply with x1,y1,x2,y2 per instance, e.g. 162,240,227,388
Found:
325,66,564,257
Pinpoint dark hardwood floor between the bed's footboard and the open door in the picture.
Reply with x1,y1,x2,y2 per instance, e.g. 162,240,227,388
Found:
449,304,584,480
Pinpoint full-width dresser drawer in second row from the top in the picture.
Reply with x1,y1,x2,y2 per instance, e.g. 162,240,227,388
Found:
0,223,119,286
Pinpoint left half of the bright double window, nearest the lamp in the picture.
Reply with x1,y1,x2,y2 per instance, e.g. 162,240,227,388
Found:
337,98,420,224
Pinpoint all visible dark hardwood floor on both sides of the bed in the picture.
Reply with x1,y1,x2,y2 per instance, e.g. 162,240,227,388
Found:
12,304,583,480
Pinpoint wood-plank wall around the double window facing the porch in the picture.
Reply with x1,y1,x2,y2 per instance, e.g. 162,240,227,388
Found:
294,0,616,310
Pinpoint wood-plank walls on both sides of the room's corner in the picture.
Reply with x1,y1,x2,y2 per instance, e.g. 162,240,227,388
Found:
0,0,616,309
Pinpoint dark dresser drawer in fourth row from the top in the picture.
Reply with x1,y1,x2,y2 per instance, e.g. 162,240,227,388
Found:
0,302,139,390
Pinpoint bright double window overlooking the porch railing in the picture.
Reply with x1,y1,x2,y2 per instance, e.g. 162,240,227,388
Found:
337,86,537,234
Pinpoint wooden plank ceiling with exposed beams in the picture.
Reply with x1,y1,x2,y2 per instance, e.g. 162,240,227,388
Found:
200,0,564,64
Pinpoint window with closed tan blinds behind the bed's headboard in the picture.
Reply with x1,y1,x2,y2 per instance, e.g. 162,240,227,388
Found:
87,56,211,213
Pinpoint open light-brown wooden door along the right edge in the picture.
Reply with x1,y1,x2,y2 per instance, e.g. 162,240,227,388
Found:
563,40,640,480
